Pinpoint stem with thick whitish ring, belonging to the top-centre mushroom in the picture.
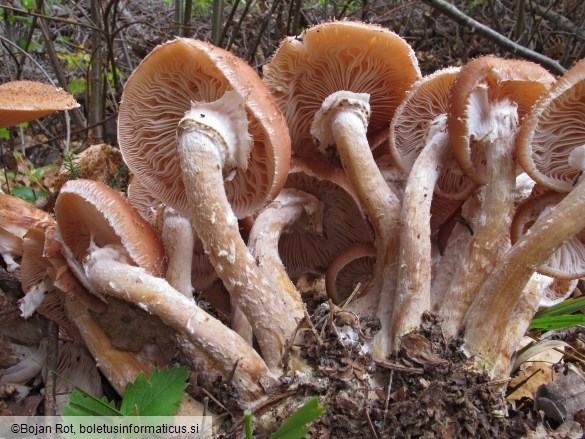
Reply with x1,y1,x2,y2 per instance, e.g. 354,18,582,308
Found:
311,91,400,359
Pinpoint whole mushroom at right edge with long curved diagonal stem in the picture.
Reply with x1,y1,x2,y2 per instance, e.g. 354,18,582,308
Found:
464,55,585,375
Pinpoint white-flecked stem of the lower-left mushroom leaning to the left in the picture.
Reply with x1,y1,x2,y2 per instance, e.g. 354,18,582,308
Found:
84,247,278,401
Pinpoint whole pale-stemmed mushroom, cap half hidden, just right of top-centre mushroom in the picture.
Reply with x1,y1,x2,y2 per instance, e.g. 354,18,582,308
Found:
389,68,476,342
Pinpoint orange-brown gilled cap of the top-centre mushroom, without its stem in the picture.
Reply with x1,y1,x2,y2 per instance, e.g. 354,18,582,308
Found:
264,21,420,155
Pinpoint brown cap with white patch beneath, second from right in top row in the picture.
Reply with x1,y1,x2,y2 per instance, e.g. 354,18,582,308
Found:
448,55,555,184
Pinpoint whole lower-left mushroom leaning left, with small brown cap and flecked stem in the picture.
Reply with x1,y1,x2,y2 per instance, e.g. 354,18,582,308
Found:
55,180,271,400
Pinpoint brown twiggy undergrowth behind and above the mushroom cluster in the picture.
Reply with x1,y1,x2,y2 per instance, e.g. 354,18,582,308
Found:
0,0,585,192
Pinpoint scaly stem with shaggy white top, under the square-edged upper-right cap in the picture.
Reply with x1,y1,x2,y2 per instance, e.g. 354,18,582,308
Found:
439,91,518,337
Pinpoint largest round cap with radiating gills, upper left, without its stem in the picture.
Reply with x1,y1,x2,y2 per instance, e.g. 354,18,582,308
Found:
118,38,290,218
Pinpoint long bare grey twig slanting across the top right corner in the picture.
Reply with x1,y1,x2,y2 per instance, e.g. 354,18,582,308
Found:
423,0,566,75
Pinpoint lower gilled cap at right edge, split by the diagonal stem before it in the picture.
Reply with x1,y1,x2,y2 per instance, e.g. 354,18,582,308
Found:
510,192,585,280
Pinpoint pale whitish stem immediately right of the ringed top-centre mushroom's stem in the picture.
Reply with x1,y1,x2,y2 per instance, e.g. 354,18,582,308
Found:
392,114,450,340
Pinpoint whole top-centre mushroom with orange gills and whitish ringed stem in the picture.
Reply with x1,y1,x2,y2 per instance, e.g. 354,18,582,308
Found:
264,21,420,358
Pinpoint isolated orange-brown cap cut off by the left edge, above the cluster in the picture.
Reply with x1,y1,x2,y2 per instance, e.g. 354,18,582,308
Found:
0,81,79,128
